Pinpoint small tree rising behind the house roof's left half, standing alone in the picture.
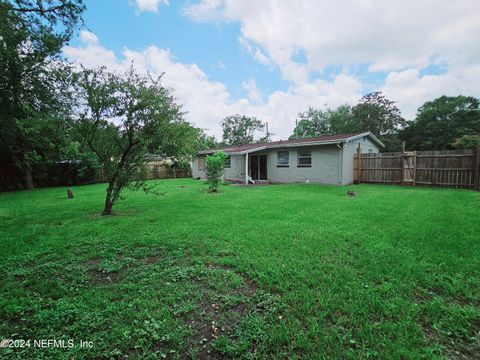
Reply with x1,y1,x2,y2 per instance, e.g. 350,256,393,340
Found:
222,114,264,145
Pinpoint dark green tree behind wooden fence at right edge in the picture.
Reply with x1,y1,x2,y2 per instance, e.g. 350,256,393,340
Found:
399,96,480,150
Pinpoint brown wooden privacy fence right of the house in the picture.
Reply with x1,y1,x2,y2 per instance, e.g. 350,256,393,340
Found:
353,150,480,190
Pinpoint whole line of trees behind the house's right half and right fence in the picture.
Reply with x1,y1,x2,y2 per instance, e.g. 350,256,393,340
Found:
291,92,480,151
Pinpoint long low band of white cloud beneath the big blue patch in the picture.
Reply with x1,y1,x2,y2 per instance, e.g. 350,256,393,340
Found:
63,33,362,138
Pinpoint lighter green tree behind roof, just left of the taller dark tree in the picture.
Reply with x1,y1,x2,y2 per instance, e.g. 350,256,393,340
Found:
290,105,353,139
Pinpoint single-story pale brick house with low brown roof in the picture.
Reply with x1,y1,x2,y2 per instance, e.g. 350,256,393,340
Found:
192,132,384,185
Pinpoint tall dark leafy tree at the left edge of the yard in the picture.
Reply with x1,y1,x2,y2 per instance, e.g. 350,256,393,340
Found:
0,0,85,188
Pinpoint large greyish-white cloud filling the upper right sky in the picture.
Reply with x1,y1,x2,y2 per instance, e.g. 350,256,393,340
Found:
184,0,480,118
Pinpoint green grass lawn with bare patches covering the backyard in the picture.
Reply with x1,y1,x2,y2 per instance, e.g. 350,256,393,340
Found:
0,179,480,359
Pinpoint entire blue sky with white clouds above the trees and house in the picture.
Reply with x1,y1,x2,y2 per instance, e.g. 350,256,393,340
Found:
63,0,480,139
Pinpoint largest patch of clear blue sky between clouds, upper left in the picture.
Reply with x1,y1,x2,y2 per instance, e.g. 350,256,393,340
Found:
72,0,288,98
